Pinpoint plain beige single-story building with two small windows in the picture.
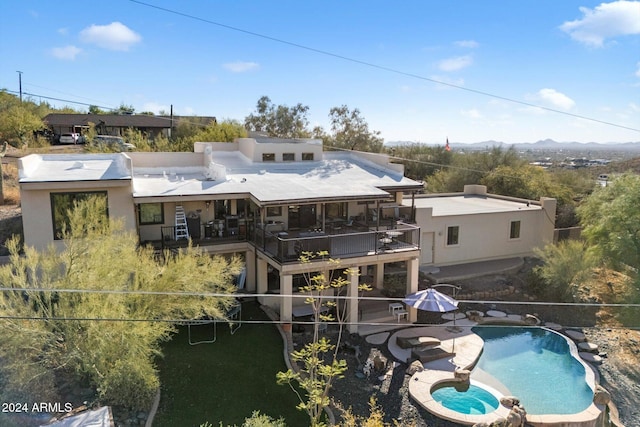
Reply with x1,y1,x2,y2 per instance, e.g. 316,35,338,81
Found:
405,185,556,266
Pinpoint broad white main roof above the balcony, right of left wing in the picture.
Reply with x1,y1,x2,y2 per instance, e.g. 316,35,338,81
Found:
133,151,421,203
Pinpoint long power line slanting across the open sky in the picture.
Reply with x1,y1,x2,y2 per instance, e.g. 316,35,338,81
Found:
129,0,640,132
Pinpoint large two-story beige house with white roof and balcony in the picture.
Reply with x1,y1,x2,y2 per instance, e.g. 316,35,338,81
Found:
19,138,423,332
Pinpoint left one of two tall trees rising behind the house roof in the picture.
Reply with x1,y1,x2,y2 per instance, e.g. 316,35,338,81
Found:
244,96,311,138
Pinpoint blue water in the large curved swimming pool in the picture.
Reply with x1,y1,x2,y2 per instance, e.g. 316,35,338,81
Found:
473,326,593,415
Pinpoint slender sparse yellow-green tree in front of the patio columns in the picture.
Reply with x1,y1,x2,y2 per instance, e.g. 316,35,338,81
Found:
277,251,371,427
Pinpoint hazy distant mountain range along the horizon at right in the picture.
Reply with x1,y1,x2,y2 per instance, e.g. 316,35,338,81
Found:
385,139,640,152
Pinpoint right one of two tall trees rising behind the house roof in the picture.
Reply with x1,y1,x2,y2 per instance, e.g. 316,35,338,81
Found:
327,105,384,153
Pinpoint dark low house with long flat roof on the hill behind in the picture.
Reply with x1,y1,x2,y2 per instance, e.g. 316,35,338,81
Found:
43,113,216,139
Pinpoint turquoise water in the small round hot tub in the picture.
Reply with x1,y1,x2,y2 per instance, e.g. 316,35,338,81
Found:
431,384,500,415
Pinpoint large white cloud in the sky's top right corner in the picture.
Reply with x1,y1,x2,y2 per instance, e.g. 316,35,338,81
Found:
560,0,640,47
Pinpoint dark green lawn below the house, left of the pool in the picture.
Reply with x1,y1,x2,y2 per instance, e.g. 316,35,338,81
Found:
153,303,309,427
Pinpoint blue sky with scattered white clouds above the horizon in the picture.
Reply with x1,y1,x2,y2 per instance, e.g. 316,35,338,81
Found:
0,0,640,143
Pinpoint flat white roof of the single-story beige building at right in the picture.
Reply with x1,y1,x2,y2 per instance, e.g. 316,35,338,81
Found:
404,195,542,216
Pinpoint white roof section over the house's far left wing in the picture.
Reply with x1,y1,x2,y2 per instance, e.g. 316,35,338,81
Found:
20,154,132,183
